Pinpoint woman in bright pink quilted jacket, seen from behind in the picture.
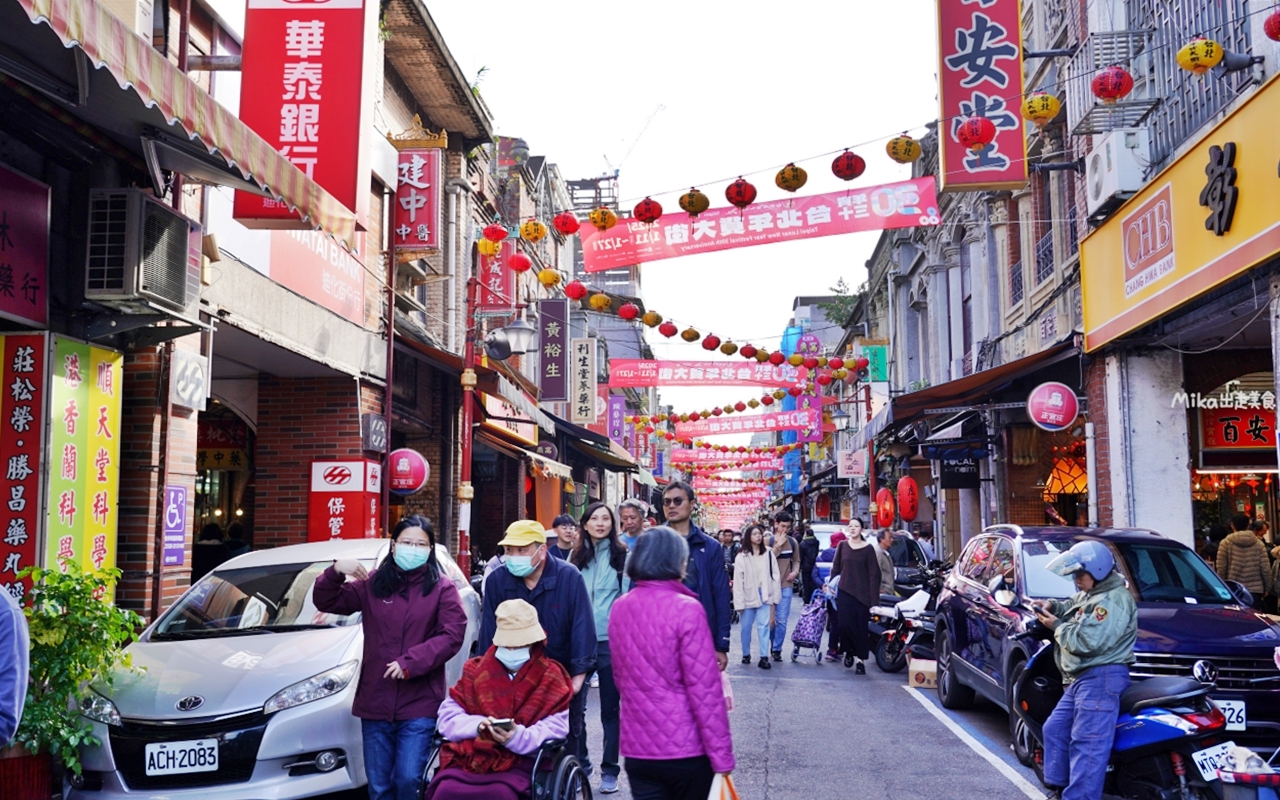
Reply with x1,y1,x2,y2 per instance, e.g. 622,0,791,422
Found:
609,526,733,800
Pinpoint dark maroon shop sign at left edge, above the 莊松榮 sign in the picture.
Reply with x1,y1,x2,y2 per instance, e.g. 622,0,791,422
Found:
0,166,50,328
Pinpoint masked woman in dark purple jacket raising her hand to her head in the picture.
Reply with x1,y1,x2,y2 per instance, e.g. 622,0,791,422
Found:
312,516,467,800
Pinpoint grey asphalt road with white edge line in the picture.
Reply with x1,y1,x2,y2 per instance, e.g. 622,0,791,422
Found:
588,600,1043,800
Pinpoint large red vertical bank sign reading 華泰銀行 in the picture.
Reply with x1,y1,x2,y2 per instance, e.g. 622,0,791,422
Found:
234,0,381,228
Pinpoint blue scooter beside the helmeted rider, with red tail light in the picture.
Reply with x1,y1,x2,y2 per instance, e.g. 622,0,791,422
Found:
1012,623,1235,800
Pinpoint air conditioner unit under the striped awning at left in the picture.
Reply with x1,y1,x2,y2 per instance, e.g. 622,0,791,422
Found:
84,189,201,314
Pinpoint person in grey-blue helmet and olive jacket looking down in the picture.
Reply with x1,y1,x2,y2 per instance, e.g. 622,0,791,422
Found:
1032,540,1138,800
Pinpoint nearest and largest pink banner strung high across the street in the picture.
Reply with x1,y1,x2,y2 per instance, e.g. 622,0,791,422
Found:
579,176,942,273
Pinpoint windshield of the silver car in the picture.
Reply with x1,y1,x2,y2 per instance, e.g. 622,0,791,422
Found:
151,561,372,640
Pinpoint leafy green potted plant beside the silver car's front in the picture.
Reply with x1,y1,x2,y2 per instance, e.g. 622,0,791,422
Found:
0,561,143,800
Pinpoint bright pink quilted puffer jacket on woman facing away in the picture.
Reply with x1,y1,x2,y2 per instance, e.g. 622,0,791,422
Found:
609,581,733,772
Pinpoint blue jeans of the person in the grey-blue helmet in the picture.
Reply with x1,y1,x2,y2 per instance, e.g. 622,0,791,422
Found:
1044,664,1129,800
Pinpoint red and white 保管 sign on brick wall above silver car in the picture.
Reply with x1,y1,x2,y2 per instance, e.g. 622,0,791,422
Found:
307,460,383,541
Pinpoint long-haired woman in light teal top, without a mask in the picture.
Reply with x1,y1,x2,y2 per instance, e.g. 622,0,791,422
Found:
570,503,627,795
